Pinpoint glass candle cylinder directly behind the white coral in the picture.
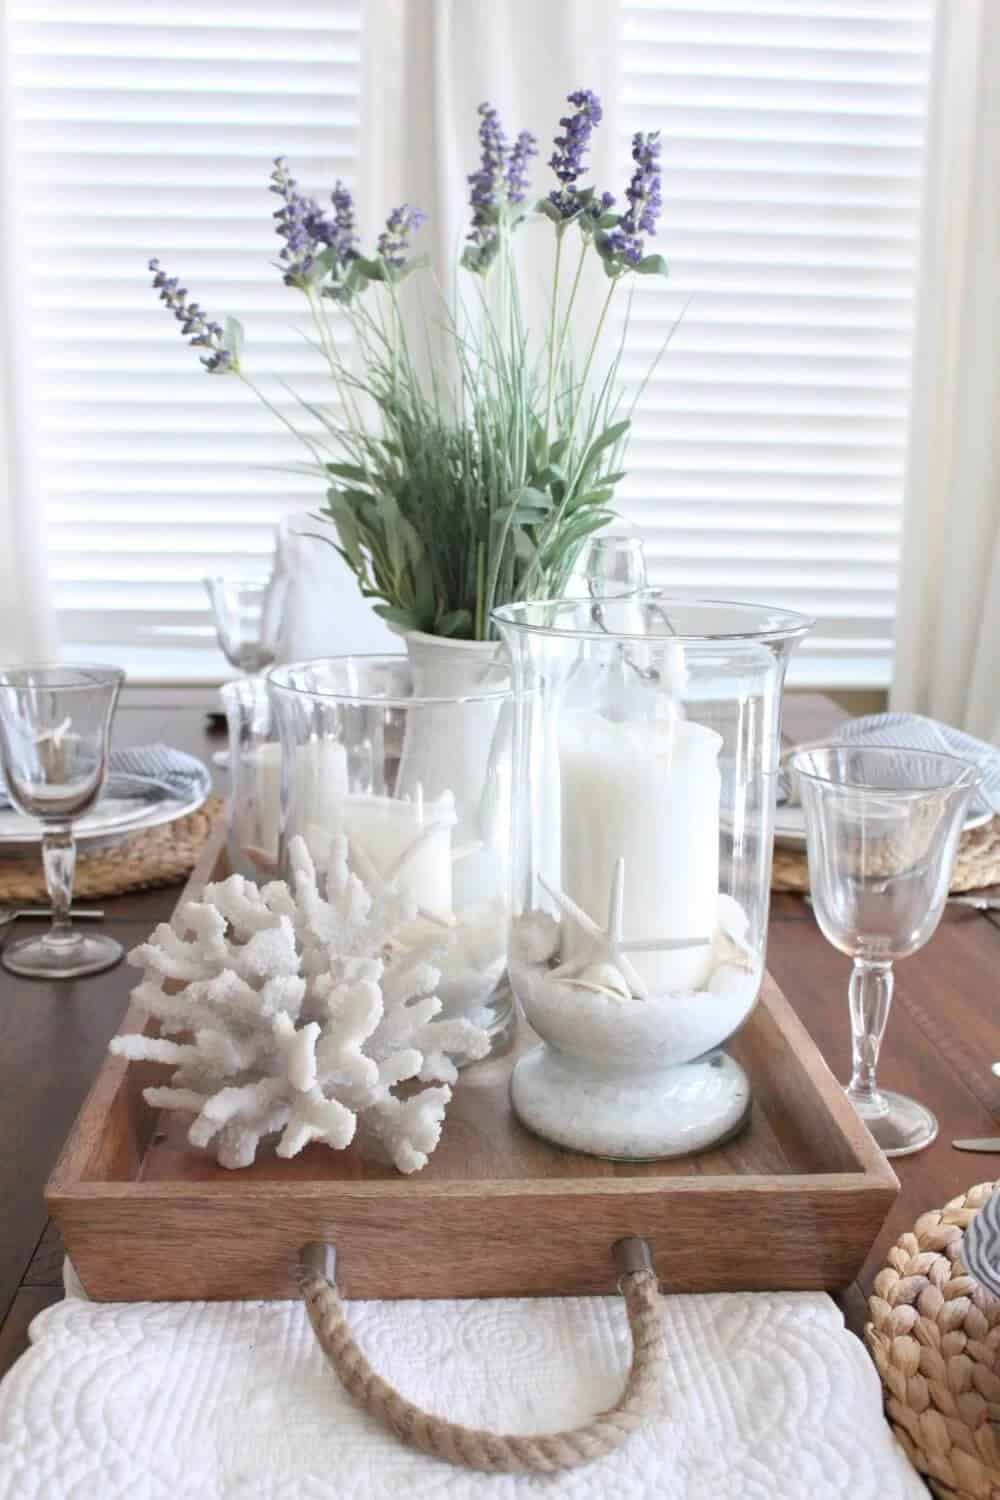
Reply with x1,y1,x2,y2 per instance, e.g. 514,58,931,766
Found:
268,648,514,1049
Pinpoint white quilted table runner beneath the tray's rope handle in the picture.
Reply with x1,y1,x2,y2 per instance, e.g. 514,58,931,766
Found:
0,1293,927,1500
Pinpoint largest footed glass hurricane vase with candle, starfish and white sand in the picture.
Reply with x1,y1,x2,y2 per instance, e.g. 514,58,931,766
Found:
495,590,810,1160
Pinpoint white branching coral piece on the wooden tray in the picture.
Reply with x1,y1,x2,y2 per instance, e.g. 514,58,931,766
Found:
111,836,489,1172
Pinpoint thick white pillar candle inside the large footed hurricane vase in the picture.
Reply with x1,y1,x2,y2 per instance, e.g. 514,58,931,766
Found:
559,713,723,995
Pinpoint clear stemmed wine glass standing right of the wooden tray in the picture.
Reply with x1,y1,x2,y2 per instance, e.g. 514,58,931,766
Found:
790,746,979,1157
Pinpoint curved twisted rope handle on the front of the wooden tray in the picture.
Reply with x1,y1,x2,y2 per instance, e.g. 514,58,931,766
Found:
300,1236,666,1475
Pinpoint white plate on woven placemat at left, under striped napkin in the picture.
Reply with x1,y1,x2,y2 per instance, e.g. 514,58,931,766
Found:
0,767,211,857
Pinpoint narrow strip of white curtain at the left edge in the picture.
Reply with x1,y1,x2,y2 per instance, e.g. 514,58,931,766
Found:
0,0,55,666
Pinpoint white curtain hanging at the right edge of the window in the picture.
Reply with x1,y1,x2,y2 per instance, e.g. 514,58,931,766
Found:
891,0,1000,741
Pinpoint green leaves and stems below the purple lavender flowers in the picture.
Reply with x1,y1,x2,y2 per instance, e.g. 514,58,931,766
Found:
242,207,666,641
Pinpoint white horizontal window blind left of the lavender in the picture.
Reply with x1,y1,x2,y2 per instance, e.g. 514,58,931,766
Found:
9,0,361,681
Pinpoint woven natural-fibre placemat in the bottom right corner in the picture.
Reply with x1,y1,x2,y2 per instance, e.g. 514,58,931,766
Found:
865,1182,1000,1500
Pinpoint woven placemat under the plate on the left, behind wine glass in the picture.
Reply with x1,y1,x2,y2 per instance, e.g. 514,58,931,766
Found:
0,797,225,906
